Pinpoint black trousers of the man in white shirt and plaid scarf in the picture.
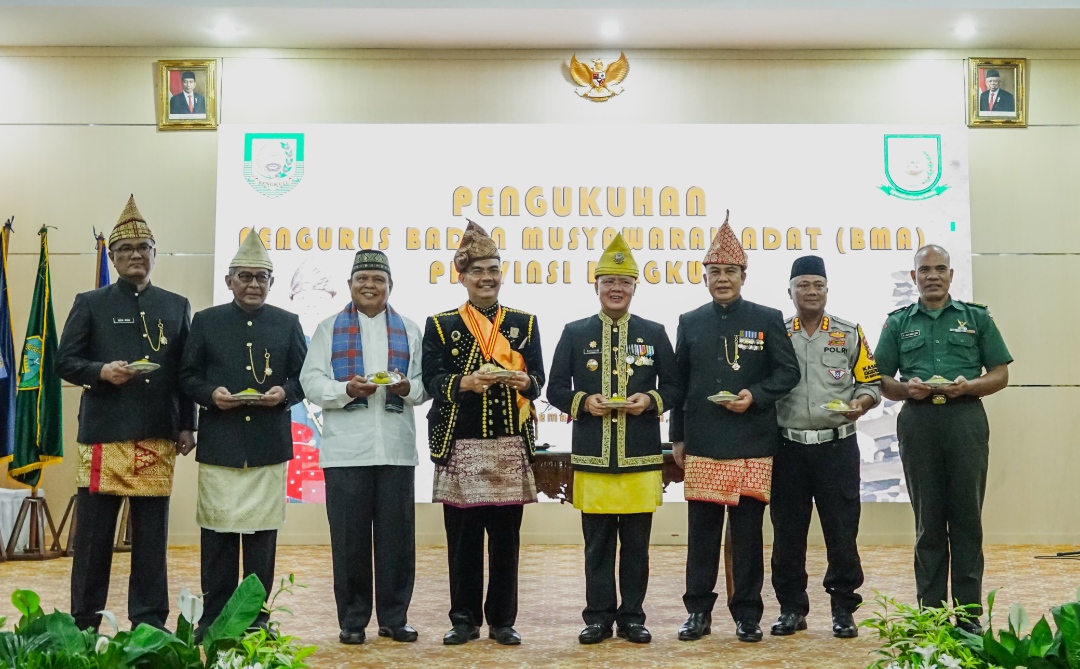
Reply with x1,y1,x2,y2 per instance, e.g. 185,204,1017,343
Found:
323,465,416,632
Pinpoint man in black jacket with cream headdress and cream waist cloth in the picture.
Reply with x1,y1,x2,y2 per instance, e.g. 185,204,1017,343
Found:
180,229,308,638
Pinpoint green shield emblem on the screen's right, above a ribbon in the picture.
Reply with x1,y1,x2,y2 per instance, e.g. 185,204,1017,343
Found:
878,135,949,200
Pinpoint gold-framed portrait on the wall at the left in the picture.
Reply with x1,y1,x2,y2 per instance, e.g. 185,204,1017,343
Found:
157,58,217,130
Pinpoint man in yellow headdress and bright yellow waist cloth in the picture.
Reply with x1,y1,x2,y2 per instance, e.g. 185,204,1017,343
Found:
548,233,681,643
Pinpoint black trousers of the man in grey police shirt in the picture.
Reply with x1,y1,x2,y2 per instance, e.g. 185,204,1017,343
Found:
769,434,863,616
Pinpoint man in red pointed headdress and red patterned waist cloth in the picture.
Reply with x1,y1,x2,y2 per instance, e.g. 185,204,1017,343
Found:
670,212,799,642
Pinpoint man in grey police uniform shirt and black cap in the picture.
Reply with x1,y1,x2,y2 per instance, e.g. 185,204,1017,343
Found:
770,255,881,639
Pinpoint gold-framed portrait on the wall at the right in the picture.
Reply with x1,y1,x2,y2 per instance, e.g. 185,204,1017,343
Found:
968,58,1027,128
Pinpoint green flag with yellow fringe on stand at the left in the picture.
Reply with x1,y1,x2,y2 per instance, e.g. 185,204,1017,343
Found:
8,228,64,490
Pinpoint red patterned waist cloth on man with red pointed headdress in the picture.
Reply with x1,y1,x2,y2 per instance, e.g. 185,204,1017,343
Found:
683,455,772,506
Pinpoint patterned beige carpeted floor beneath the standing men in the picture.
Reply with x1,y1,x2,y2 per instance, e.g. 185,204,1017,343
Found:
0,546,1080,669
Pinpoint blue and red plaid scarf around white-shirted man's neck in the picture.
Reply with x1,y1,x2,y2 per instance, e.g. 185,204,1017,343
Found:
330,302,409,414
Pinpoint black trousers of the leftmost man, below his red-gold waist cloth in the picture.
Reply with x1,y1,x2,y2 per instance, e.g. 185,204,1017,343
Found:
71,487,168,629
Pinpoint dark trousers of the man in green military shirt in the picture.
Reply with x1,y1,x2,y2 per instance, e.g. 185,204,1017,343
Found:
896,402,990,612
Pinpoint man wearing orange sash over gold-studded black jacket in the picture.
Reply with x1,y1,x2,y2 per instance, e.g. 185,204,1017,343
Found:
423,220,544,645
